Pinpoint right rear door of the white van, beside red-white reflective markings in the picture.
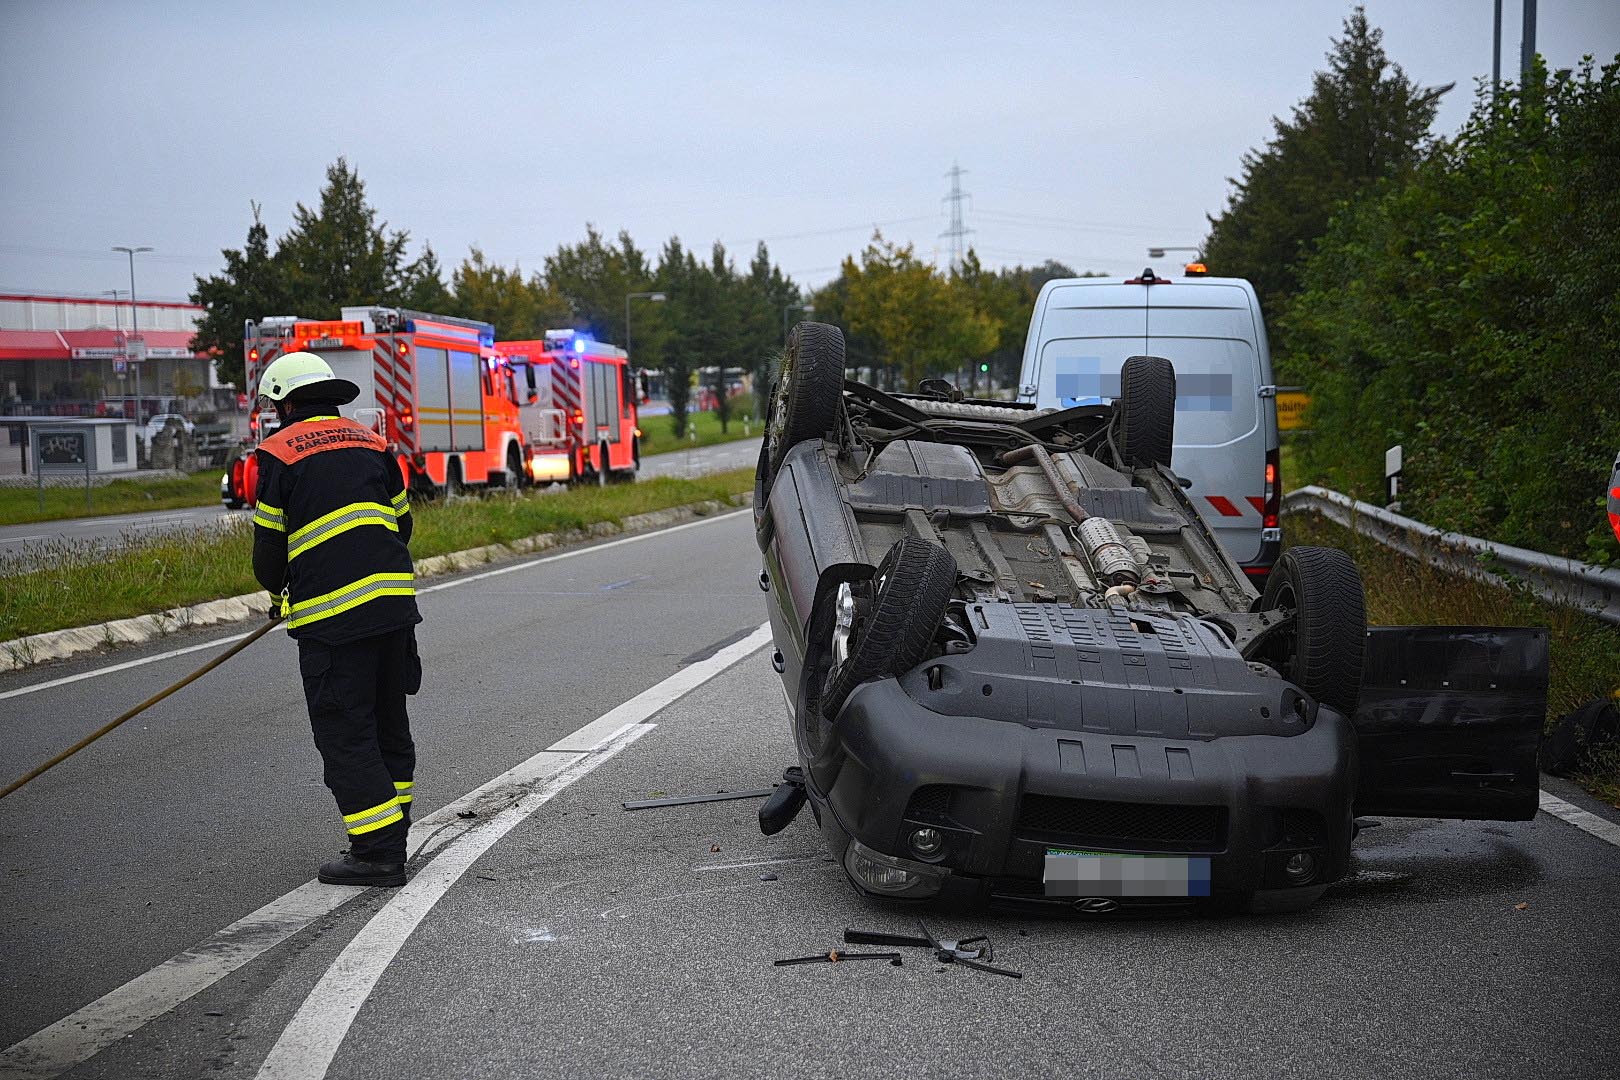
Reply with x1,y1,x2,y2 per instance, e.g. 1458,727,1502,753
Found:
1142,280,1270,562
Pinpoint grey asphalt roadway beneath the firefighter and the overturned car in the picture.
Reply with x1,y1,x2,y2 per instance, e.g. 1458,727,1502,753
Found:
0,513,1620,1078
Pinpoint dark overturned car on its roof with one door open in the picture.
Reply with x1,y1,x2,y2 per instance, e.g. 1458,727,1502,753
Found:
755,322,1547,912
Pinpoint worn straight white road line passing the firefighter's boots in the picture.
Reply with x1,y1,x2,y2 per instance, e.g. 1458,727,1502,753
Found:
0,621,771,1080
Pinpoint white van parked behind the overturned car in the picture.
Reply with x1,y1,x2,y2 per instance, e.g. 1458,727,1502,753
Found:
1019,270,1283,588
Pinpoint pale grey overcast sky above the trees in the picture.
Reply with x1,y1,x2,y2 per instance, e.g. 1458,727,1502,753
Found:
0,0,1620,306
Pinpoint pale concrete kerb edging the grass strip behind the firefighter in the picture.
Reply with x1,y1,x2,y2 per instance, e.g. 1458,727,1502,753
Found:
0,494,753,670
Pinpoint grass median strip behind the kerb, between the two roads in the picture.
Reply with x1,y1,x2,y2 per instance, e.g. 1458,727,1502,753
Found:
0,470,753,641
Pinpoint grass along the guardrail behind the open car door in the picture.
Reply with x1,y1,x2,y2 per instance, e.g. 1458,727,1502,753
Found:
1285,513,1620,805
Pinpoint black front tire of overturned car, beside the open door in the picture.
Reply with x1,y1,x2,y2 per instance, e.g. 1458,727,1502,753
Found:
1260,547,1367,716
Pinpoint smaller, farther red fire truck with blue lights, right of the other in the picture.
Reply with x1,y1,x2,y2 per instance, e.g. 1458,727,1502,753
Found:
496,330,642,484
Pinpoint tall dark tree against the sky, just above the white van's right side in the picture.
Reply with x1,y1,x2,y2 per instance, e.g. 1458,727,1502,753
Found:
1204,6,1452,319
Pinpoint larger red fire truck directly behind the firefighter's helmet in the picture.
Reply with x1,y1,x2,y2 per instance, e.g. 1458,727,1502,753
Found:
220,308,528,507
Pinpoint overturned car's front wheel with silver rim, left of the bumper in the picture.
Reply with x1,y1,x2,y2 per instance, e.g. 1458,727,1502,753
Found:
820,536,956,717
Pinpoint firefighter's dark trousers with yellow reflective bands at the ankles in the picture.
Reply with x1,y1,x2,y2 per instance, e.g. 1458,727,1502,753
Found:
298,627,421,863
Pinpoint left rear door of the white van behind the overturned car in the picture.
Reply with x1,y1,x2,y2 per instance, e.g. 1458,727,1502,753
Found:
1021,283,1149,408
